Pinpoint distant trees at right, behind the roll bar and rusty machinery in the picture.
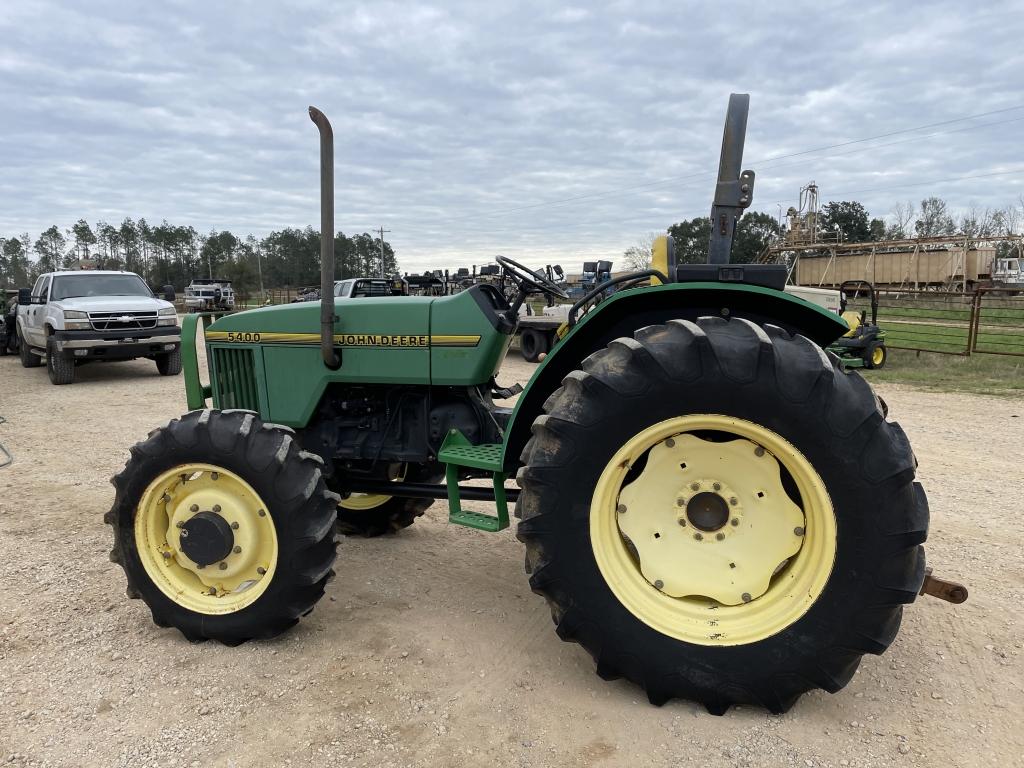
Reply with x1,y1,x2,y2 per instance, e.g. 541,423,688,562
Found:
623,197,1024,269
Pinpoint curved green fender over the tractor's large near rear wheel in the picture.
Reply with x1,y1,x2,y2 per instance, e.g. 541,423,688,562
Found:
503,283,848,473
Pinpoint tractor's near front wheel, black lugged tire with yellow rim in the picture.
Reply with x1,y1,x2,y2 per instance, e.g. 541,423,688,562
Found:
103,411,338,645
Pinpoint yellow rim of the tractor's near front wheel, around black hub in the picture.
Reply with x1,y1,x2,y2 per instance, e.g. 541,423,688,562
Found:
135,464,278,615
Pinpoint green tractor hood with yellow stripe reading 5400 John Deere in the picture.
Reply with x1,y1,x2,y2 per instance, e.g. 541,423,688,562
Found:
206,292,511,427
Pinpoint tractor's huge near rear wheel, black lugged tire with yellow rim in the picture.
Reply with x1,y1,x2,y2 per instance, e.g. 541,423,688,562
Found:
517,317,928,714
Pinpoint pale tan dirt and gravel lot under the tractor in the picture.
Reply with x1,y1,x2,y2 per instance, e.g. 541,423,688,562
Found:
0,353,1024,768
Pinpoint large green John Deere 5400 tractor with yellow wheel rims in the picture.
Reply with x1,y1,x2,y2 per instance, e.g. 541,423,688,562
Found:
105,95,966,714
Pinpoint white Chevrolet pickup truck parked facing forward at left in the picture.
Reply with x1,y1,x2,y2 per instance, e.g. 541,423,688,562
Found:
17,270,181,391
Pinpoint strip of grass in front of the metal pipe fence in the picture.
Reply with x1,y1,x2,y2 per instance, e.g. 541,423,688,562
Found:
863,349,1024,396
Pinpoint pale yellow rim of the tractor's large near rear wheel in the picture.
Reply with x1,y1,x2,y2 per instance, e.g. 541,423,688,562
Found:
590,415,837,646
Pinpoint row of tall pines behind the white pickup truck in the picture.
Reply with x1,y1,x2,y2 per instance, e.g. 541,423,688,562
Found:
0,218,398,296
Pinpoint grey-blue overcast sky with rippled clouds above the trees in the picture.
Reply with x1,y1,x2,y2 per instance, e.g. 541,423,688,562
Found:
0,0,1024,271
